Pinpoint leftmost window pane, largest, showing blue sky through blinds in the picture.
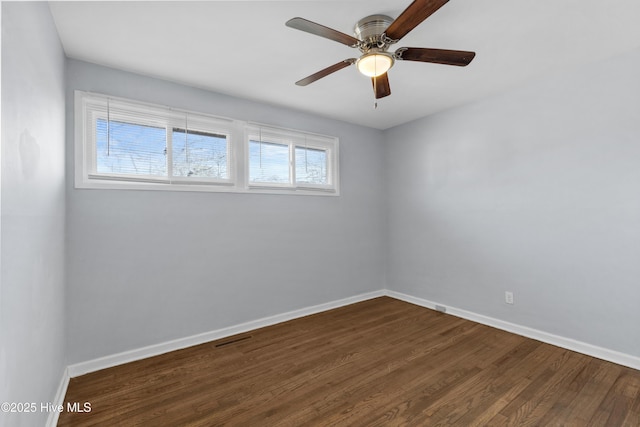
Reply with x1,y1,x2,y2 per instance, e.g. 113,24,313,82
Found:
96,119,167,176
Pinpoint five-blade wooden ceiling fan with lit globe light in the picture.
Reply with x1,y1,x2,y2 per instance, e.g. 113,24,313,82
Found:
286,0,476,99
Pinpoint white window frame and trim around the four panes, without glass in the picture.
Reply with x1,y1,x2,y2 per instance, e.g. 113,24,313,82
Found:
75,90,339,196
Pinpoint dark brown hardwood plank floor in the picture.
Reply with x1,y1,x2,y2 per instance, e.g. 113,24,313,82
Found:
58,297,640,427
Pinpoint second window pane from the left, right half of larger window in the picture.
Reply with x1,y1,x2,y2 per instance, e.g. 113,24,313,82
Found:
171,129,229,179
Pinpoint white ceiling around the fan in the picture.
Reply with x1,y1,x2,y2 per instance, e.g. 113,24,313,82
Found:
51,0,640,129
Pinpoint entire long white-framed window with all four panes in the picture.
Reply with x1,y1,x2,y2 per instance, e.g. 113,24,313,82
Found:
76,91,338,194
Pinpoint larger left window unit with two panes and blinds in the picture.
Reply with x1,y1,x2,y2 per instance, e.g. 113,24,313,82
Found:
80,94,232,185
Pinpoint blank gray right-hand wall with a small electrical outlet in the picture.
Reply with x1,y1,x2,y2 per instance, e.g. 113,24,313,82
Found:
384,50,640,356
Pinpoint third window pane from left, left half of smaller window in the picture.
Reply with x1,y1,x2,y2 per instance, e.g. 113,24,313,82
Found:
249,141,291,184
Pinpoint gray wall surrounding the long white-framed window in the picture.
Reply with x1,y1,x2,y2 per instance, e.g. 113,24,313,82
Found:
67,60,386,363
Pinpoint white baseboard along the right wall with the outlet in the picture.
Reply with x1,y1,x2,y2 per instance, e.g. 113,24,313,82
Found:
386,290,640,370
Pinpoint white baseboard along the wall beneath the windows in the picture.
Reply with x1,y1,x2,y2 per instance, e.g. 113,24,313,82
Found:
63,290,386,378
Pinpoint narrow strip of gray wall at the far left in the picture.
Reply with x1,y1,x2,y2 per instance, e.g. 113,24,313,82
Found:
0,2,66,426
